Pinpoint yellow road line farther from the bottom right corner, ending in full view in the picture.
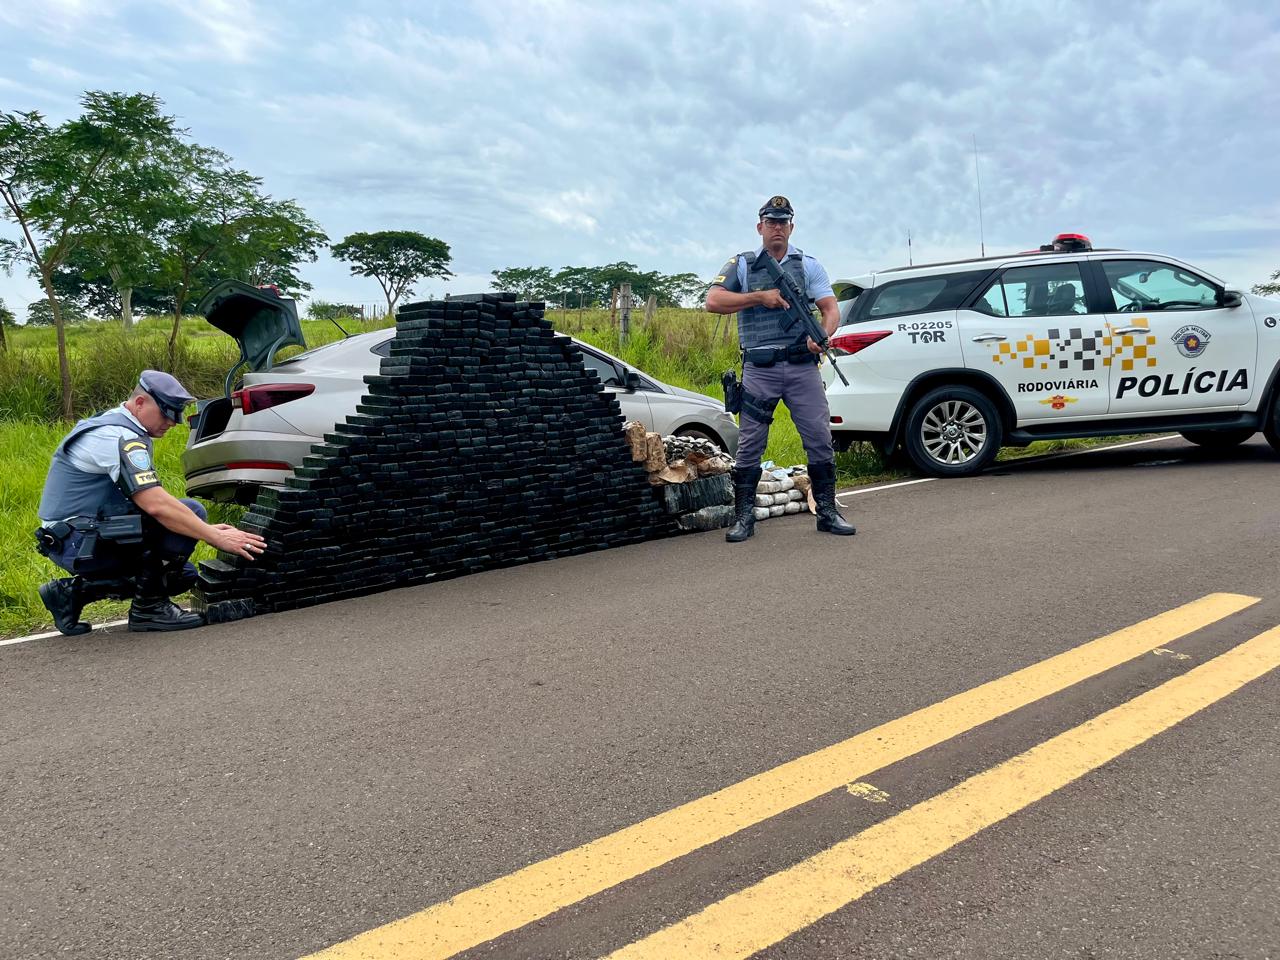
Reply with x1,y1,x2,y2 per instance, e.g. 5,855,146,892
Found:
305,594,1258,960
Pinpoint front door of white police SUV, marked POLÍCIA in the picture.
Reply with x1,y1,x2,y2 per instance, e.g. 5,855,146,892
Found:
1094,256,1258,416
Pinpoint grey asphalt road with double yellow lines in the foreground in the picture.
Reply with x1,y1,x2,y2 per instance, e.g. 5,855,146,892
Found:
0,436,1280,960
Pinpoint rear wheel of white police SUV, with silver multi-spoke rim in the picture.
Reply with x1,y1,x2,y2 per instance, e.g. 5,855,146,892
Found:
904,387,1005,477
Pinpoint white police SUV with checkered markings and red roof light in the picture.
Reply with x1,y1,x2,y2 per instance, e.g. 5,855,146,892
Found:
823,233,1280,476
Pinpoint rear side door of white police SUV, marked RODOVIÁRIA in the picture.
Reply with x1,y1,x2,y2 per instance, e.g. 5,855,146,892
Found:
957,260,1107,424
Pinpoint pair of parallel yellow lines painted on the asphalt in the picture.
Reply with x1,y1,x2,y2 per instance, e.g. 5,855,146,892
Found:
308,594,1280,960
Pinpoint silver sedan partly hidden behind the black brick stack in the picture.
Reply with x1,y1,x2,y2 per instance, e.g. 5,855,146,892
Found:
182,329,737,503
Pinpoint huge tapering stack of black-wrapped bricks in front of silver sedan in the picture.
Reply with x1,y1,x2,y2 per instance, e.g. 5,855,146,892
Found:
195,294,677,622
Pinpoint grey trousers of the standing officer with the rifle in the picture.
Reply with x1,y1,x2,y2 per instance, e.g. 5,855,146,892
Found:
737,362,836,470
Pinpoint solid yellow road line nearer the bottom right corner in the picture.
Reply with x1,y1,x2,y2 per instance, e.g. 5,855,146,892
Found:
607,627,1280,960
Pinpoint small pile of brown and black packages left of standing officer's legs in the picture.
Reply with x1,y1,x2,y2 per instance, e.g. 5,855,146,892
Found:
622,420,733,531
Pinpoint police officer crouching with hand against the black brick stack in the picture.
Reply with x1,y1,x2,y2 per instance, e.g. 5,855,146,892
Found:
36,370,266,636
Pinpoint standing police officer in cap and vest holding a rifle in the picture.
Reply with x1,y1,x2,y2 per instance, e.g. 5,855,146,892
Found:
707,197,856,543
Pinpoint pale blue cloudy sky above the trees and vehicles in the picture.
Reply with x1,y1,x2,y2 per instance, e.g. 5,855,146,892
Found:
0,0,1280,315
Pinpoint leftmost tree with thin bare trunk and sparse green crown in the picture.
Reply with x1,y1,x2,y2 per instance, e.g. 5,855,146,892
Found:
0,91,175,420
